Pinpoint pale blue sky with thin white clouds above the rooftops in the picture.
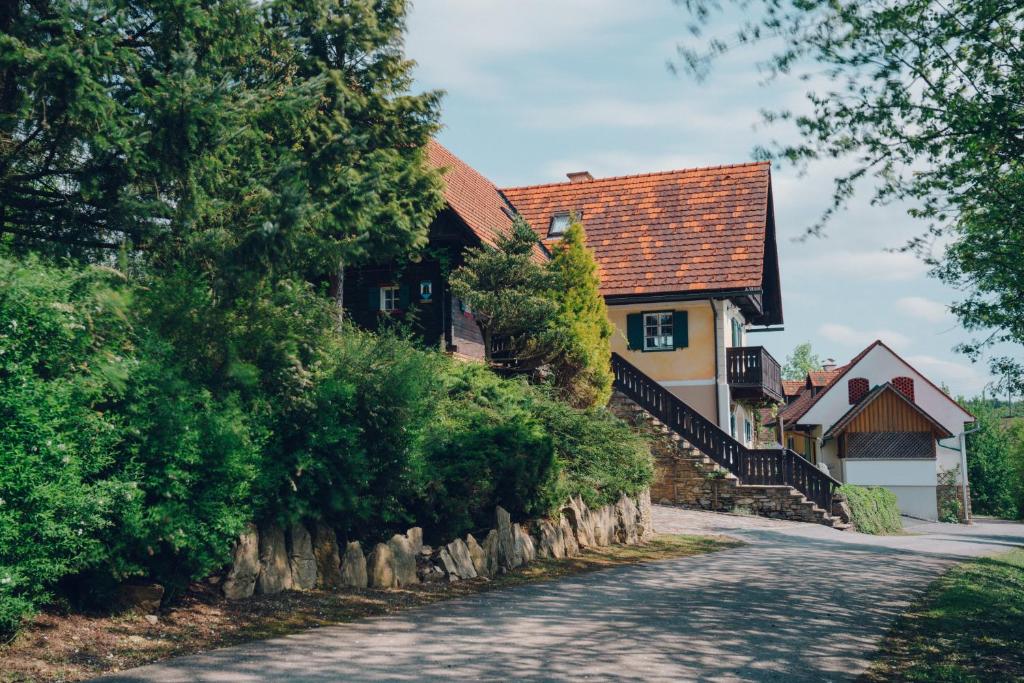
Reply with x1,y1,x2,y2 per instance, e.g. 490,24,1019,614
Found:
407,0,1007,396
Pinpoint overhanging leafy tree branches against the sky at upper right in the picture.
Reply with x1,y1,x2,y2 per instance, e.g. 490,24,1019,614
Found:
677,0,1024,389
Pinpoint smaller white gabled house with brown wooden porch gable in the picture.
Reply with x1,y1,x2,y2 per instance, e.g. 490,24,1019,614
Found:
776,341,974,519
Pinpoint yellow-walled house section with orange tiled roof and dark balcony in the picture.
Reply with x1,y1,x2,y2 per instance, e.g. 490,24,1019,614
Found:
503,163,782,438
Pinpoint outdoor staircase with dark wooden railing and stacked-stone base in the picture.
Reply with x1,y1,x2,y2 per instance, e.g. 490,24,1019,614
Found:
611,354,850,529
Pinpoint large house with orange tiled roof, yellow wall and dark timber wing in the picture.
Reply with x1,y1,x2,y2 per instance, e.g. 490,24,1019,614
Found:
344,141,783,445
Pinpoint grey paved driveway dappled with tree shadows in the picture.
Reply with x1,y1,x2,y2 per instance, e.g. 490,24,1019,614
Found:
101,507,1024,682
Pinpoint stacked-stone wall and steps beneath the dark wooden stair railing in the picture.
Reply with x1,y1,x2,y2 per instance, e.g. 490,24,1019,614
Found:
609,391,846,528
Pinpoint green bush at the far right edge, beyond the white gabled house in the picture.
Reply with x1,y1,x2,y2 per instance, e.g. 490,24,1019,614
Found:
966,400,1020,517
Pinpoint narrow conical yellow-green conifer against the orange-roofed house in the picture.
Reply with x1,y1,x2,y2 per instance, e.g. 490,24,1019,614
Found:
550,219,614,408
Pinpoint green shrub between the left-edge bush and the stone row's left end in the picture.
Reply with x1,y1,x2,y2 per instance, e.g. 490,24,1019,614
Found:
104,335,264,589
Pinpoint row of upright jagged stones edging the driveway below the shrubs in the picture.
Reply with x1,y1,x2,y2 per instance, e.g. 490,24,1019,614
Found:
222,492,653,600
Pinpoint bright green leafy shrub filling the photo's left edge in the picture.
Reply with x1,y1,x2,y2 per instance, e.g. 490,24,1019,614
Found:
0,259,136,632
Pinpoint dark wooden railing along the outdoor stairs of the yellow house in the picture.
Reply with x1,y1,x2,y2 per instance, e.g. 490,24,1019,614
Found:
611,353,841,513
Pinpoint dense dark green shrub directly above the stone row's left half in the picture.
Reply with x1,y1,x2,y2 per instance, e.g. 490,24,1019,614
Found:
260,329,444,539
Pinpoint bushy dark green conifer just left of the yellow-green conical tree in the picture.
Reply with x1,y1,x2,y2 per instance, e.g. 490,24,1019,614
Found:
449,222,558,368
